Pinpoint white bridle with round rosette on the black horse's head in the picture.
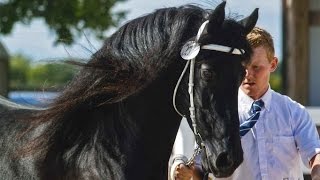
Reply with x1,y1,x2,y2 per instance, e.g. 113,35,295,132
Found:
173,20,245,165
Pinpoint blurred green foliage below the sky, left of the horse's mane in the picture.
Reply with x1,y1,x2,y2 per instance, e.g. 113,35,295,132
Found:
9,55,78,90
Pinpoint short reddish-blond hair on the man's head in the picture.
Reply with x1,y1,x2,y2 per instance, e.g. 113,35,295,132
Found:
247,27,274,61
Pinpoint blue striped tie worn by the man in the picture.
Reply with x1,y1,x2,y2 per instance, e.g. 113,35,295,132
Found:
240,99,264,137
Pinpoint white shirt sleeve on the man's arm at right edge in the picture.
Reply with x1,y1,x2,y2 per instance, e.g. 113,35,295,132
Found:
292,105,320,167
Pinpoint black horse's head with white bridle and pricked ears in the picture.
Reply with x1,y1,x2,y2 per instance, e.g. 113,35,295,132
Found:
177,2,258,177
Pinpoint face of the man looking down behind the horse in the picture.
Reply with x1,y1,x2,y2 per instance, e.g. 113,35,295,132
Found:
240,46,278,100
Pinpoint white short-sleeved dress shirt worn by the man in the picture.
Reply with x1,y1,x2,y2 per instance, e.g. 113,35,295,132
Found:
216,88,320,180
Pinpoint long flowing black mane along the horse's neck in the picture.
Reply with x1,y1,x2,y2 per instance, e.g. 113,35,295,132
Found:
20,5,208,179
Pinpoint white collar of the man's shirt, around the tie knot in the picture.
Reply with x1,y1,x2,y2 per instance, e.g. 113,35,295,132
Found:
238,84,272,111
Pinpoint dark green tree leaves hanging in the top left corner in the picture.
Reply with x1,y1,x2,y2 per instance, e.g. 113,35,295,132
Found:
0,0,126,44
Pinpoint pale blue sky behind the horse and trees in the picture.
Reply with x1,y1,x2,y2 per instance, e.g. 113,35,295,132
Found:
0,0,282,61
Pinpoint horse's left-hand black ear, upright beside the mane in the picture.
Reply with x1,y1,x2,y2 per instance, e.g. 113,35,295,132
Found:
207,1,226,33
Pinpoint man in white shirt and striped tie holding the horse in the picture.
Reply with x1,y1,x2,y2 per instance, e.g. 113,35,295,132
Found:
171,27,320,180
